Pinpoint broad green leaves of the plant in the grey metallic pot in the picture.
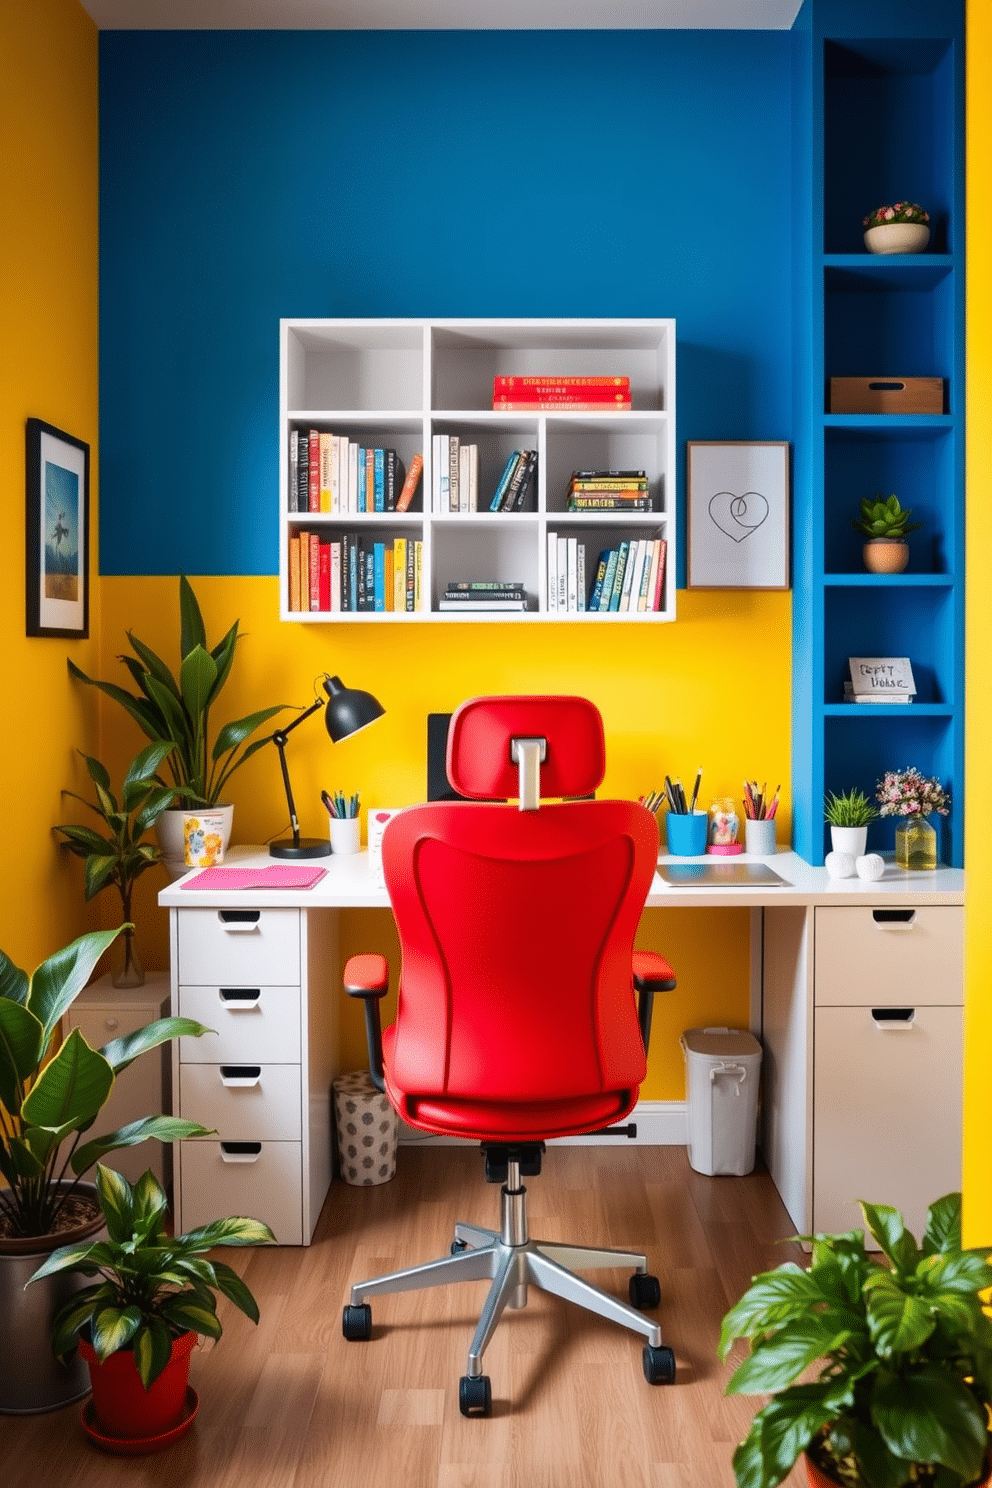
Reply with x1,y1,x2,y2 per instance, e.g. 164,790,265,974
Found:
0,930,210,1240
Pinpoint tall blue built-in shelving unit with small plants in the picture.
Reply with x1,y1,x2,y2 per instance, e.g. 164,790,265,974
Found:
793,0,965,866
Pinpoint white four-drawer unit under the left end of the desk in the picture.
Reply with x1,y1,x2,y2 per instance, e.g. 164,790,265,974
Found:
171,906,341,1245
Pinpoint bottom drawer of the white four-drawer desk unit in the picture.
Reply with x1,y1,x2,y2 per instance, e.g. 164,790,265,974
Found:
180,1138,309,1245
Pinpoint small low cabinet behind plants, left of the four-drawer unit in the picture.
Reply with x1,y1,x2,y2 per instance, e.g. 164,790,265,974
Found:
65,972,173,1184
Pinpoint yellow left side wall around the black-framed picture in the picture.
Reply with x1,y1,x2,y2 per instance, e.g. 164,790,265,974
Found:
0,0,100,969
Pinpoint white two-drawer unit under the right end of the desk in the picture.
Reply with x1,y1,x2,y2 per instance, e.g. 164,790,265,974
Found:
763,892,964,1238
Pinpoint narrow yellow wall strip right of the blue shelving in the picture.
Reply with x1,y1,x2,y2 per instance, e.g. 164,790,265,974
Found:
964,0,992,1245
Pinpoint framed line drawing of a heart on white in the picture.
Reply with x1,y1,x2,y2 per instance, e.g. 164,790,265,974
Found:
686,440,790,589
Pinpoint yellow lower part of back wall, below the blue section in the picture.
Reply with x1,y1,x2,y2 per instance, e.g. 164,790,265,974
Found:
98,577,791,1100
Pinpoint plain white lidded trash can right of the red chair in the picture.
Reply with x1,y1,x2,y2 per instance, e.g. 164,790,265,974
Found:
680,1028,761,1177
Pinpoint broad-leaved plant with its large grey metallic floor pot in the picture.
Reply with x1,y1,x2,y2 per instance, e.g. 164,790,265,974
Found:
0,930,207,1414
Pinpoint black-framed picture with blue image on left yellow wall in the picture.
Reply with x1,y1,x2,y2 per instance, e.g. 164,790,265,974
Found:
27,418,89,637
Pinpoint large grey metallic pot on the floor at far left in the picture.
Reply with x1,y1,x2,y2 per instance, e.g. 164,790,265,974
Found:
0,1183,107,1415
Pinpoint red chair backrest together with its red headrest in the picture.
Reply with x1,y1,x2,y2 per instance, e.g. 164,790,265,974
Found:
382,698,657,1103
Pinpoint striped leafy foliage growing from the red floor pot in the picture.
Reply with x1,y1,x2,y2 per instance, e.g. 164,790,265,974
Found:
28,1164,275,1390
